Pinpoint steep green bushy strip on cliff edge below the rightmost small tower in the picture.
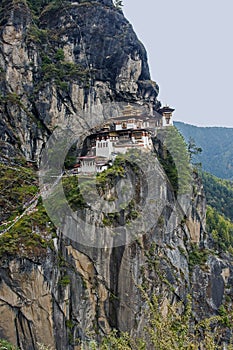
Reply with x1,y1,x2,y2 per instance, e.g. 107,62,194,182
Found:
155,127,192,195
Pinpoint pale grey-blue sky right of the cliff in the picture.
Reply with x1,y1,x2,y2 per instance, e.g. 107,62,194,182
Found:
123,0,233,127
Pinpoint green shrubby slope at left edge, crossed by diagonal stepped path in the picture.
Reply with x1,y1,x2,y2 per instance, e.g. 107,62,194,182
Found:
0,164,56,257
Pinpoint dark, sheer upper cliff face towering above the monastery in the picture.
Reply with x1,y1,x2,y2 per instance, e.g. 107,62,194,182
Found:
0,1,159,165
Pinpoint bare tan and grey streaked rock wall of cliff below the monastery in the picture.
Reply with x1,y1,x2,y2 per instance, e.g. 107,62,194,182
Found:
0,159,233,350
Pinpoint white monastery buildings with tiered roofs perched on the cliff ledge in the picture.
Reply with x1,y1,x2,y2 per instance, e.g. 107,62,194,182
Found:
79,106,174,174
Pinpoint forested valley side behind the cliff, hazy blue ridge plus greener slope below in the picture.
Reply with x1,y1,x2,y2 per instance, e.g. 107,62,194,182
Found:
175,122,233,253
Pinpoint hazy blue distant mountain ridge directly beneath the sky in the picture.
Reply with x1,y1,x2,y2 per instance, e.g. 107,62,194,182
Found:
174,122,233,179
